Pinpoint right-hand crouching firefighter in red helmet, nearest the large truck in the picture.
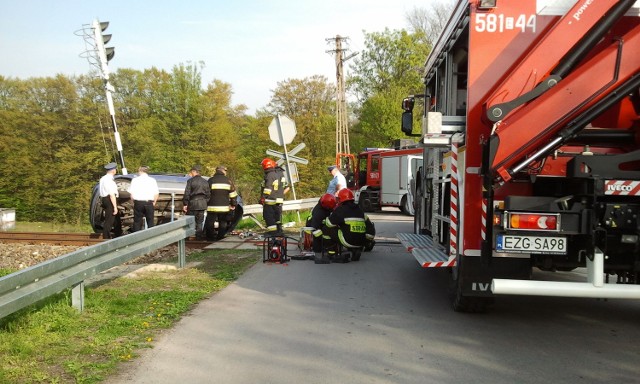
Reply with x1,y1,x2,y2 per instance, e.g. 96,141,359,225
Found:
324,188,375,263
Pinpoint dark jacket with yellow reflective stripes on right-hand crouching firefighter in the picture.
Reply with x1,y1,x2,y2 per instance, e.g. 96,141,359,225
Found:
325,200,375,248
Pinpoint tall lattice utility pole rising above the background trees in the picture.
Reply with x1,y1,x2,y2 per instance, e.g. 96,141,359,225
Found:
325,35,358,166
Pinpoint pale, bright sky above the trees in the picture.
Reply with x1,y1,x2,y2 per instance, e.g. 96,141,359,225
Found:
0,0,442,113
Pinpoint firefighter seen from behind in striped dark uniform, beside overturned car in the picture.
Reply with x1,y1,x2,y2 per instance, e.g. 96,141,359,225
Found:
204,165,238,241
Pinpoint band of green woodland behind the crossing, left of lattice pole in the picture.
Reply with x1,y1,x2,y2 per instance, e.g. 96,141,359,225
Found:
0,68,335,223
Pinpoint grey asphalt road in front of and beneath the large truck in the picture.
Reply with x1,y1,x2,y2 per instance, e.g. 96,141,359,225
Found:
107,211,640,384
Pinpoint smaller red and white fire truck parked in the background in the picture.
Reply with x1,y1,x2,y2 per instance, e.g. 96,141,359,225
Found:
351,148,422,215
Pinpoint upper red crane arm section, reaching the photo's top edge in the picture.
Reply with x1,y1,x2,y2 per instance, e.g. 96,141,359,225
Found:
486,0,635,122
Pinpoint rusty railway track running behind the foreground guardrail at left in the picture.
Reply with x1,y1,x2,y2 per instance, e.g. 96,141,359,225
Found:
0,232,211,248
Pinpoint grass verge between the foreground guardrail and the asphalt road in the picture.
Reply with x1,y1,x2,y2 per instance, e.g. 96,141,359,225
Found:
0,250,261,383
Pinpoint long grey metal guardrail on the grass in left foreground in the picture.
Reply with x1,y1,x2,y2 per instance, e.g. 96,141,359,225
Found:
0,216,196,318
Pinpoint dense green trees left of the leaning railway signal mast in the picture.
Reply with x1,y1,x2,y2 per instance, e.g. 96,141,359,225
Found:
0,75,104,222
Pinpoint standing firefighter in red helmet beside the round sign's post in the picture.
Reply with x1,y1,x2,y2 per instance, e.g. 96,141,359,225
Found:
260,158,289,235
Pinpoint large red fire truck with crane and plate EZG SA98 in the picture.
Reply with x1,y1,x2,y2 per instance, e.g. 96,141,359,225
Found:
398,0,640,311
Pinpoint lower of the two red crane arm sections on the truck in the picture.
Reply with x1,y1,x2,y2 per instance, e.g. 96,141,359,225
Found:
489,20,640,181
